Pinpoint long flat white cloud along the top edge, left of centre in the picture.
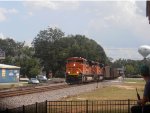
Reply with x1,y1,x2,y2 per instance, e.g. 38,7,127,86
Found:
24,0,79,11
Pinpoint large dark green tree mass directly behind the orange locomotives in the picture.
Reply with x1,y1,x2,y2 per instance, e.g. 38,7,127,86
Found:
32,28,107,75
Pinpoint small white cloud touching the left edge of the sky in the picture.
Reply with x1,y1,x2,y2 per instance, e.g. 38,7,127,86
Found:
0,8,18,22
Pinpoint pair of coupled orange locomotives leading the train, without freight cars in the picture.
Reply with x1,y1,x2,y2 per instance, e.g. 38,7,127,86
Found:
66,57,103,83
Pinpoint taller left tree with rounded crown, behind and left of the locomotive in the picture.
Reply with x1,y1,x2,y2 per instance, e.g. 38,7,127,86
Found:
32,28,64,75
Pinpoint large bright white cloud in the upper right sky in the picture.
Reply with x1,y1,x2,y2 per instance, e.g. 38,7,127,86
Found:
87,1,147,28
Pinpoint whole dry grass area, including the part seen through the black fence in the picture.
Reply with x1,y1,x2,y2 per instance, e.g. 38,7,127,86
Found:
48,79,145,113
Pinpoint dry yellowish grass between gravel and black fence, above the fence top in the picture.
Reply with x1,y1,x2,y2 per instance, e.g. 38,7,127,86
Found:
64,79,145,100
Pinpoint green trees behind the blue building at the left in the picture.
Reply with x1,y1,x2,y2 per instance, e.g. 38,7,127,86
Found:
0,38,40,77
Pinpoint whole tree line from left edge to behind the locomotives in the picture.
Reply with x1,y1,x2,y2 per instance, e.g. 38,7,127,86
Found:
0,27,109,78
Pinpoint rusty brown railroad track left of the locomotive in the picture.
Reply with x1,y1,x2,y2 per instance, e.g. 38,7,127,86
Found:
0,84,70,98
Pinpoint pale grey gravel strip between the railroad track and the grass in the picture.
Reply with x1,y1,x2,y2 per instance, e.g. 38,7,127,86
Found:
0,80,122,109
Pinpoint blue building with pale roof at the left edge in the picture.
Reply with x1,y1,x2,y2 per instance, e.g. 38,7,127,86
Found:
0,64,20,83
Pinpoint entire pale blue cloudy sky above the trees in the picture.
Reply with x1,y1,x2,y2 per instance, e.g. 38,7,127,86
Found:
0,0,150,60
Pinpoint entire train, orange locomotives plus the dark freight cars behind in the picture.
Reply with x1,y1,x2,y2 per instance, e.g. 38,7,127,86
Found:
66,57,123,84
